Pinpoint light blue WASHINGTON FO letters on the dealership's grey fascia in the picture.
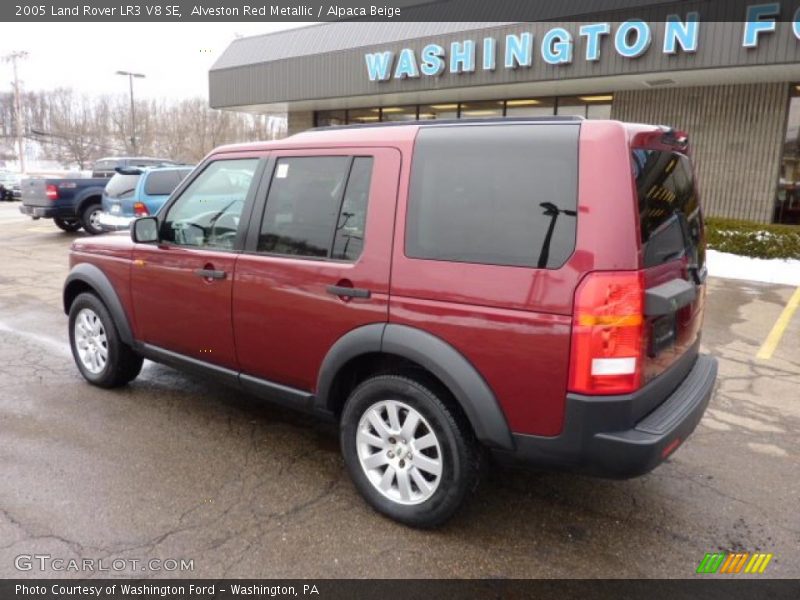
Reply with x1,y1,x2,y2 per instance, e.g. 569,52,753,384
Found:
364,2,800,81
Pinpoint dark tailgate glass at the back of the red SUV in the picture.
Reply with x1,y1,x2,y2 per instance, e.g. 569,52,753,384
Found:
632,149,705,267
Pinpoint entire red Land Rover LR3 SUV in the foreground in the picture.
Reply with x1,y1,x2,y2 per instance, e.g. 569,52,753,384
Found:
64,117,717,527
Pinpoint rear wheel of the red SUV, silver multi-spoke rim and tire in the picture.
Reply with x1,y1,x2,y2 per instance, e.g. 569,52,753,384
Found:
340,375,483,528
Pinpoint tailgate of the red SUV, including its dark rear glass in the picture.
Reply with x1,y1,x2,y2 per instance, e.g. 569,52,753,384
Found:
632,148,706,383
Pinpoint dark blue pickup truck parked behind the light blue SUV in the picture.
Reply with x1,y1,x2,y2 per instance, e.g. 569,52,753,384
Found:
20,158,180,235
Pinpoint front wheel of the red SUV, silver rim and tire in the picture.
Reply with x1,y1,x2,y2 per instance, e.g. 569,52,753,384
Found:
69,292,143,388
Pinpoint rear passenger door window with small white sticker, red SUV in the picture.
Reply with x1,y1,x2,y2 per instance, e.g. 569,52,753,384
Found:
258,156,372,260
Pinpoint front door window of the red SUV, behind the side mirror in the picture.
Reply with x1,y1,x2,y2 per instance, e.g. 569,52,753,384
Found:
162,158,258,250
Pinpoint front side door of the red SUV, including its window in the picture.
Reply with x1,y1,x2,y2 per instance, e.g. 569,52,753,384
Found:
131,158,259,369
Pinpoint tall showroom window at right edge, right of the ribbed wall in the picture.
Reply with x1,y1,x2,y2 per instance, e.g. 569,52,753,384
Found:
772,85,800,225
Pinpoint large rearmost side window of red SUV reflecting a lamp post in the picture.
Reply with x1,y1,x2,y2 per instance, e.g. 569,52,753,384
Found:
406,124,579,269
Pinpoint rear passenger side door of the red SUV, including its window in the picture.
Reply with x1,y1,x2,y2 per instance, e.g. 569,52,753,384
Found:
233,148,400,391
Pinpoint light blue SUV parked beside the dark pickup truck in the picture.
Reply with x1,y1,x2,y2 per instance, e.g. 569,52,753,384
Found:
99,166,192,231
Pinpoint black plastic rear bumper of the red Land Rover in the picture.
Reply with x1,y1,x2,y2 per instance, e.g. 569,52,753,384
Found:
495,355,717,479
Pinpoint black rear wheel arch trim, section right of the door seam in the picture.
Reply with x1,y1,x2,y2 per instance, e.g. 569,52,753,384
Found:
381,323,514,450
